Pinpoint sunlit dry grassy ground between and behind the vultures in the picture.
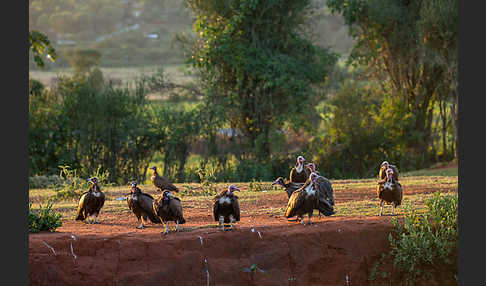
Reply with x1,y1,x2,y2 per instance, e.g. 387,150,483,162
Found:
29,164,458,222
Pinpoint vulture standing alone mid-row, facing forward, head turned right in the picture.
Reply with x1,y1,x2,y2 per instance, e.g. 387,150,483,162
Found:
213,185,240,231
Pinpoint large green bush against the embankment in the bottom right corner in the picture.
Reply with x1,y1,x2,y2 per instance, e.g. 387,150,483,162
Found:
370,192,458,285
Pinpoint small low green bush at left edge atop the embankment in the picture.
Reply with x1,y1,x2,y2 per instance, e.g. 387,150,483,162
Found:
29,201,62,232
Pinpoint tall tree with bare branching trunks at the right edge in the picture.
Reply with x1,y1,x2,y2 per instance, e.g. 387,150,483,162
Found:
327,0,457,167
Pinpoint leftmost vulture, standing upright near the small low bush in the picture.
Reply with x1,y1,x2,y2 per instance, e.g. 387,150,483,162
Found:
76,177,105,223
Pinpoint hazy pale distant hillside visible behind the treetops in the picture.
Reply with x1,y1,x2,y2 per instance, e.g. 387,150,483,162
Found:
29,0,352,70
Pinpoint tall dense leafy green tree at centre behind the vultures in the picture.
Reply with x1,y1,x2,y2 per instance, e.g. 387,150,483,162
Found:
186,0,336,161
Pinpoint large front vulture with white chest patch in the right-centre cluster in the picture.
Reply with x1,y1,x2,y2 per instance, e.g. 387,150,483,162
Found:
285,173,319,225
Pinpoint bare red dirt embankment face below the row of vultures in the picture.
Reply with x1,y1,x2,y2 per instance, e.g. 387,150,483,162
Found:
29,217,392,286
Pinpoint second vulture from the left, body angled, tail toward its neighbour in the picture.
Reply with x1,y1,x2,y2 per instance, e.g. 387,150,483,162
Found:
127,181,161,229
